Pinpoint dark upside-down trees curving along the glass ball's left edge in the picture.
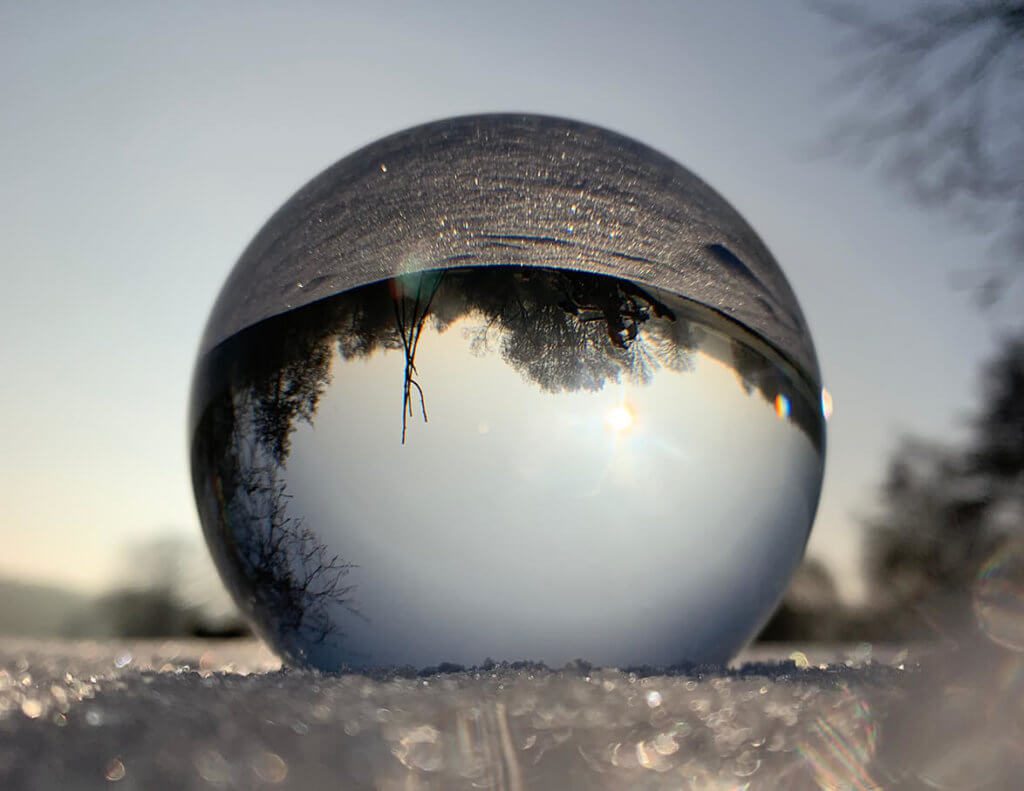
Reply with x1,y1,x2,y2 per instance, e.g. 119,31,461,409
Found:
193,366,357,655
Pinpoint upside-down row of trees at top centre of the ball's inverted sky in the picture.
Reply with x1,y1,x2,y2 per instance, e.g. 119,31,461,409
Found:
336,266,695,399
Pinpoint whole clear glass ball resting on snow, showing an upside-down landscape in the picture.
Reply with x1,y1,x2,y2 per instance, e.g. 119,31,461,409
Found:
191,116,823,669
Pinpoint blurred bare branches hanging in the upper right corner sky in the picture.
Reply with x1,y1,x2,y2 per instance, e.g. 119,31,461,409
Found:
812,0,1024,303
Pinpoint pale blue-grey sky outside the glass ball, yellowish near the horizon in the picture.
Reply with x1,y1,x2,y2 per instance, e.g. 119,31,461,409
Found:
0,0,1001,595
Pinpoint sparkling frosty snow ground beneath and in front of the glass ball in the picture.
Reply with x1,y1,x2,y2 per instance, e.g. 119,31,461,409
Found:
0,641,1024,791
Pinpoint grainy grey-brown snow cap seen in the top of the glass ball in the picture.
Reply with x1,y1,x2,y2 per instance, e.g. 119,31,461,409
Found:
201,115,820,384
